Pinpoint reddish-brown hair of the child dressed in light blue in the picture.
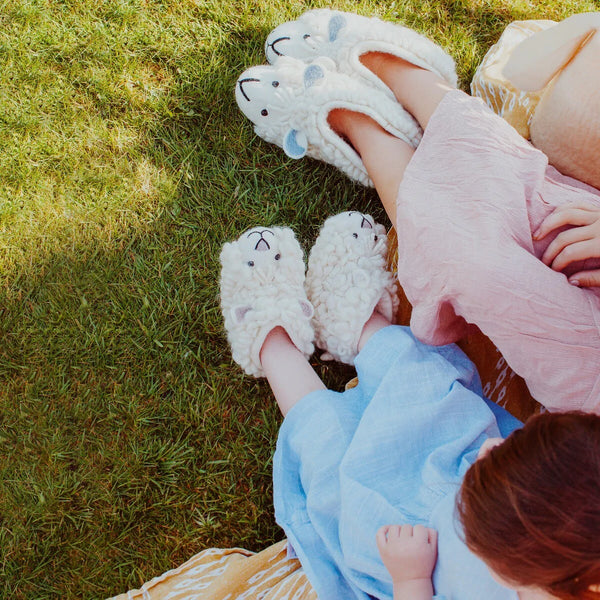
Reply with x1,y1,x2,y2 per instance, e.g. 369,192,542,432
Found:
457,412,600,600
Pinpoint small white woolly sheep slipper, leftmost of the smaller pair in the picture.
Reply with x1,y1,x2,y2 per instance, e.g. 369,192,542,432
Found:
220,227,314,377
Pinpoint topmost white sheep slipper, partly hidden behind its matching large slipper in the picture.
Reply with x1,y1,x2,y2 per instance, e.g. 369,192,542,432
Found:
265,8,457,94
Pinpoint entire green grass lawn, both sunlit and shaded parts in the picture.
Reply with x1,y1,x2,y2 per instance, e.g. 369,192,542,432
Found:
0,0,597,599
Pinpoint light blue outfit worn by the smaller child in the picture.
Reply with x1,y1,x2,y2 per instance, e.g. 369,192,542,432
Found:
273,326,521,600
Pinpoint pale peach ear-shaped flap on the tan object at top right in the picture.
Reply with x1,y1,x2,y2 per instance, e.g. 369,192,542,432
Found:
502,13,600,91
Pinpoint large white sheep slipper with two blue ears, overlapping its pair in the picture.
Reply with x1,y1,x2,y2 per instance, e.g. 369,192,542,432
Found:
235,57,421,186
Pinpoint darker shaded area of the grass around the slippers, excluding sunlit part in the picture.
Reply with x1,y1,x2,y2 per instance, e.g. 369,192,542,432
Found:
0,14,366,598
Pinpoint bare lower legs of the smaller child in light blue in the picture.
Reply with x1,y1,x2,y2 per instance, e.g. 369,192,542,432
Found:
260,312,390,417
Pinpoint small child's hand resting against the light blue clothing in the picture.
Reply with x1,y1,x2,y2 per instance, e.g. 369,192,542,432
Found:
376,525,437,586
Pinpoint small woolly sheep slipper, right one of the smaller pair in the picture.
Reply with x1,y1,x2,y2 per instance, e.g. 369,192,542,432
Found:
305,212,398,365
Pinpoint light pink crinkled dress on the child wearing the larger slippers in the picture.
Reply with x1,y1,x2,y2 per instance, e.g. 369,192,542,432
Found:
396,91,600,412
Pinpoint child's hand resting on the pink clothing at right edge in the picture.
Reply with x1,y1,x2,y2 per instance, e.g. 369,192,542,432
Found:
533,204,600,287
